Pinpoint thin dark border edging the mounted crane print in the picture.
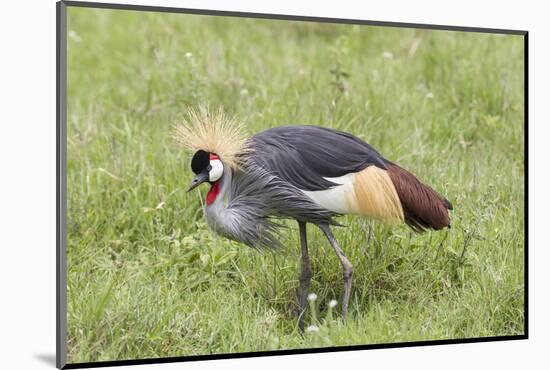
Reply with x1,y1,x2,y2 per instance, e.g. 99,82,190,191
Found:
56,0,529,369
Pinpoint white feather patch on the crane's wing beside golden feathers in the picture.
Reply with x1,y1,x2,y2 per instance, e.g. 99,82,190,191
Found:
302,173,359,214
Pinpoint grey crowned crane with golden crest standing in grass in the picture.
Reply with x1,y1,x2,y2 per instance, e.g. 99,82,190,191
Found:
175,109,452,330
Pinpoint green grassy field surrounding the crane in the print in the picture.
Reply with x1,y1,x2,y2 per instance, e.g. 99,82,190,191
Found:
67,8,524,363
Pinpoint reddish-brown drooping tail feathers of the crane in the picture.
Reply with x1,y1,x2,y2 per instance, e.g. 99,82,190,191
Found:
387,163,453,232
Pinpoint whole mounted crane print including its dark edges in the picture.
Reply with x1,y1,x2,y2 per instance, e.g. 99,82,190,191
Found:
57,2,527,368
